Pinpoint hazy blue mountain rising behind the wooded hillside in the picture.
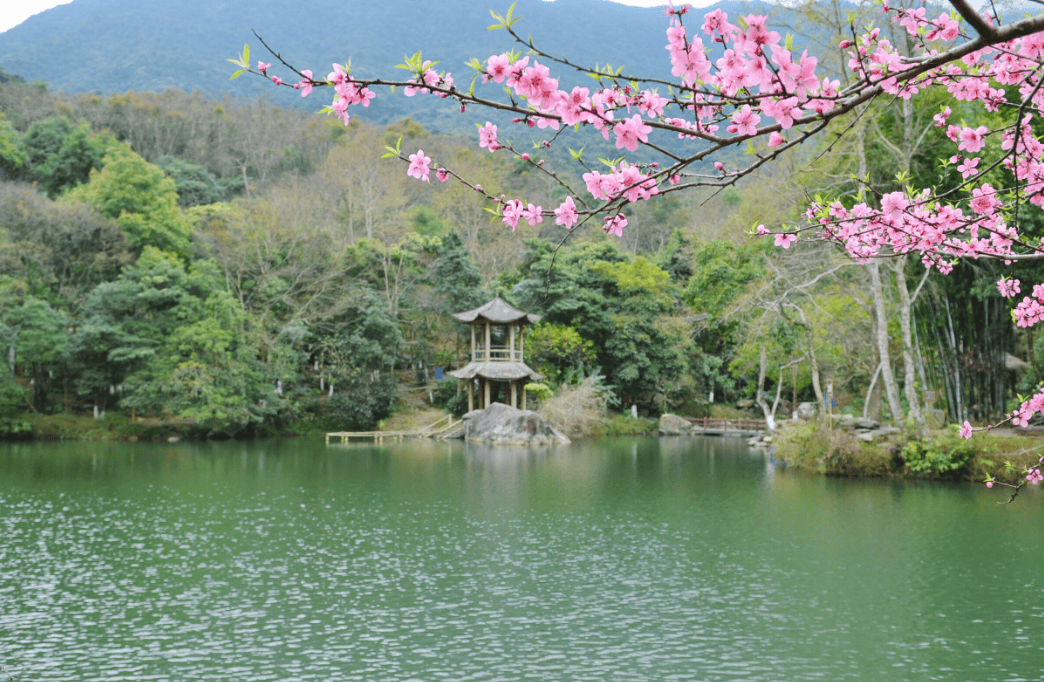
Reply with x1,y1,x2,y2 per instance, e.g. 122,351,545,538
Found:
0,0,764,130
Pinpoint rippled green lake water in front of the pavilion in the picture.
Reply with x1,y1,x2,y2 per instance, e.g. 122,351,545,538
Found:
0,439,1044,681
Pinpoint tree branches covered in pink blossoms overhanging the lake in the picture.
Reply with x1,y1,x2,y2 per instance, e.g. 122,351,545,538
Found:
242,0,1044,478
